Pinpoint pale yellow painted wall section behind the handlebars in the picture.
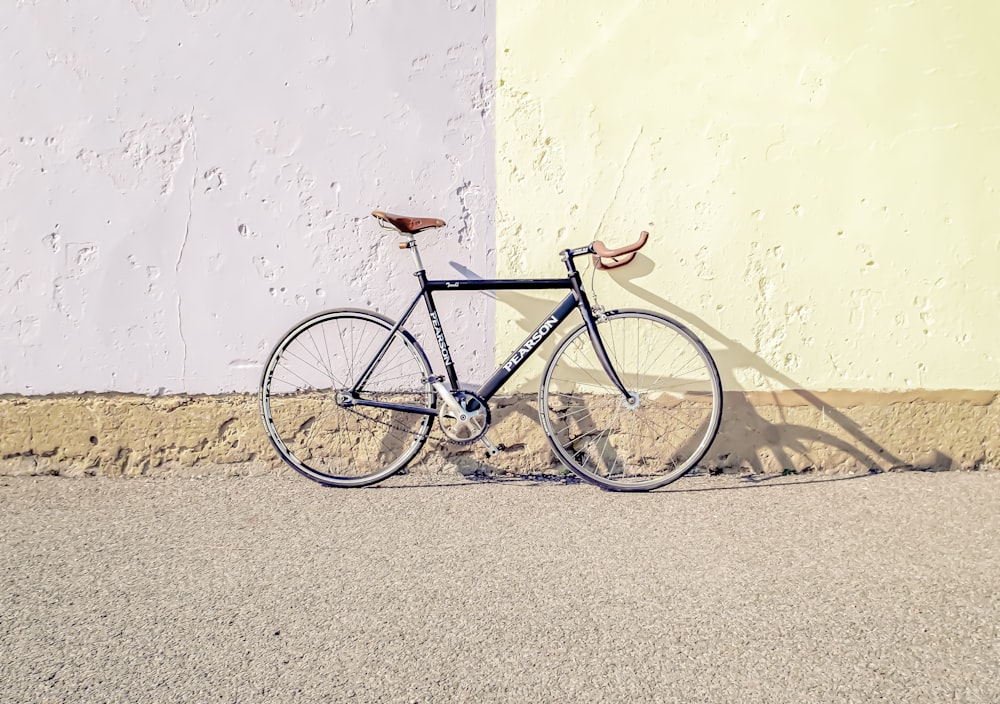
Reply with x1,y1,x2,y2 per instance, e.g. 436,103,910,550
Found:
496,0,1000,391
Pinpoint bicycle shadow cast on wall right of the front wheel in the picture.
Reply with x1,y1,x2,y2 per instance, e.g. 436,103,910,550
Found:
592,253,916,474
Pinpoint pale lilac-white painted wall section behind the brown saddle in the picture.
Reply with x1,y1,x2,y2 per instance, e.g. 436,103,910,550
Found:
0,0,495,394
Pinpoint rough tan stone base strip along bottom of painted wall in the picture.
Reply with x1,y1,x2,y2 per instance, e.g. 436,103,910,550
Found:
0,391,1000,476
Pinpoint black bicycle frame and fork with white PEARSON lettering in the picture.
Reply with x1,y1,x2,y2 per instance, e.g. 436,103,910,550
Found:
349,249,632,415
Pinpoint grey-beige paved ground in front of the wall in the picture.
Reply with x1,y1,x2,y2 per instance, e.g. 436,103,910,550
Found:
0,473,1000,703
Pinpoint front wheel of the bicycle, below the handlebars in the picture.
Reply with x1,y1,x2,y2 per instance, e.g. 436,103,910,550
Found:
538,311,722,491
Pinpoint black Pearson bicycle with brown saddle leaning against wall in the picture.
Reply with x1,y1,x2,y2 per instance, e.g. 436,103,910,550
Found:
260,210,722,491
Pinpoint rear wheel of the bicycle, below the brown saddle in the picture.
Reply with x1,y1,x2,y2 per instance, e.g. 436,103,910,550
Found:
260,309,435,487
